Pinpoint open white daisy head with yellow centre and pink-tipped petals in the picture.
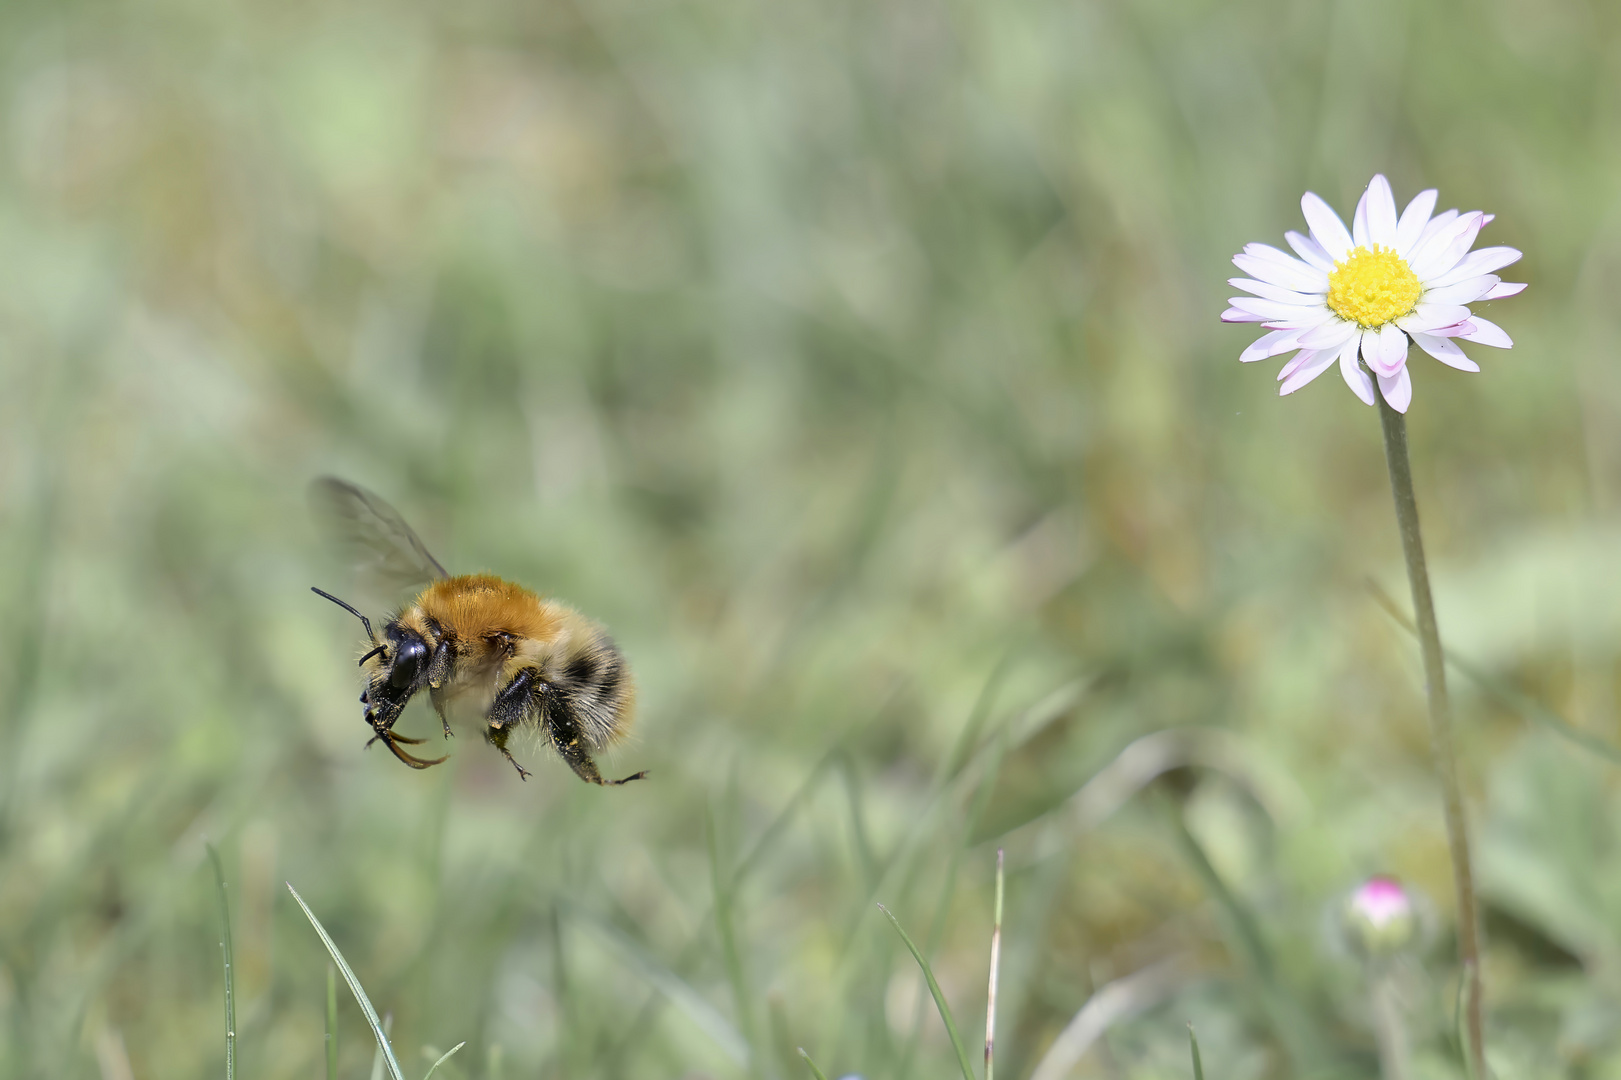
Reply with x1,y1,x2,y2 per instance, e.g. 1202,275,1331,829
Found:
1221,177,1525,412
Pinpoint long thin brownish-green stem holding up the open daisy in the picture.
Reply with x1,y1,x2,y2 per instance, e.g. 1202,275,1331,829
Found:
1378,396,1486,1080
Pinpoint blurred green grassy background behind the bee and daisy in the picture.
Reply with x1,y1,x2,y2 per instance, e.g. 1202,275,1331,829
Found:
0,0,1621,1080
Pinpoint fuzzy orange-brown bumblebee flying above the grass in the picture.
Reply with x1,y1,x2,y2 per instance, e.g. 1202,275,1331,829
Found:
310,477,647,785
